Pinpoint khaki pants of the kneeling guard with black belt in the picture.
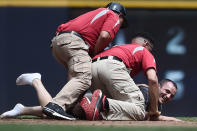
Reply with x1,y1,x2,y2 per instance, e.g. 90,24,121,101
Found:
91,57,145,120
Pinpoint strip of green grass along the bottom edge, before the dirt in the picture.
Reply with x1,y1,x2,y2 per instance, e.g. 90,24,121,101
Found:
0,124,197,131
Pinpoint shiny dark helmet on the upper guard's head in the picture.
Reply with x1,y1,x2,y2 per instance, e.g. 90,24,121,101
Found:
106,2,127,28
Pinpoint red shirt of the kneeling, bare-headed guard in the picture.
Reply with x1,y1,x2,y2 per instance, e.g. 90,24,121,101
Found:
93,43,156,77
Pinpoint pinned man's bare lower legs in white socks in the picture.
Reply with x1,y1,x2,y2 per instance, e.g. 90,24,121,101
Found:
1,73,52,118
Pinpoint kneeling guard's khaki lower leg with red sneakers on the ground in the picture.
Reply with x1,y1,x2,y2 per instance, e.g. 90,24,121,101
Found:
80,89,145,121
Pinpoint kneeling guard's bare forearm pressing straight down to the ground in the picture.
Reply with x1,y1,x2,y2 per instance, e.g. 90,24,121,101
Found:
146,68,160,117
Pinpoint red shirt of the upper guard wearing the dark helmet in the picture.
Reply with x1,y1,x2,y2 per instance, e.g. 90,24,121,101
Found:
57,8,120,54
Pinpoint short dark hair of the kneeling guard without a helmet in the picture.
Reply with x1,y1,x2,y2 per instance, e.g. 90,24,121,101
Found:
132,32,155,46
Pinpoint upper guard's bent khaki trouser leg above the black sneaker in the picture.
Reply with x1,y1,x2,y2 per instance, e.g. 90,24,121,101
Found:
52,43,91,110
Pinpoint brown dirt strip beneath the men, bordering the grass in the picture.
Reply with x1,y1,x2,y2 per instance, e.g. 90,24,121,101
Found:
0,119,197,127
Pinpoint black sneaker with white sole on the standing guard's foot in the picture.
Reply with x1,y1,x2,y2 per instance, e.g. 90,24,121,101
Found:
42,102,76,120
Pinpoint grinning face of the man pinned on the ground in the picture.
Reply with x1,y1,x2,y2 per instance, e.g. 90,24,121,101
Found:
159,82,177,104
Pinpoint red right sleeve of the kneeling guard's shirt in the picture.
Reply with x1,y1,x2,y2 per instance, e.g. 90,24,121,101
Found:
142,49,156,72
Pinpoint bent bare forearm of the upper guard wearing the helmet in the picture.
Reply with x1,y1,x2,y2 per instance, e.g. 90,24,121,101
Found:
93,31,112,56
